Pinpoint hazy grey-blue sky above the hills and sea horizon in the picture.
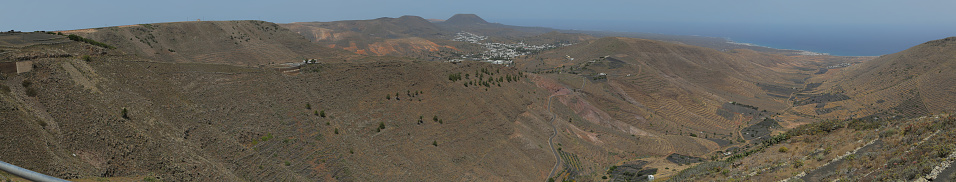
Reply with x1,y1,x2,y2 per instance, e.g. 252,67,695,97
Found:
0,0,956,55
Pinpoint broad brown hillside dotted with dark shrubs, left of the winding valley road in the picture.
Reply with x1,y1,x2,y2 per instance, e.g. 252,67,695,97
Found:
0,36,576,181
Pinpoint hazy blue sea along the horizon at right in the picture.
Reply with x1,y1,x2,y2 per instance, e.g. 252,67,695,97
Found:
500,20,956,56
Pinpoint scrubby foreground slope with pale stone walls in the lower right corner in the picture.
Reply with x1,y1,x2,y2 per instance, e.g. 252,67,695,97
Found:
667,114,956,181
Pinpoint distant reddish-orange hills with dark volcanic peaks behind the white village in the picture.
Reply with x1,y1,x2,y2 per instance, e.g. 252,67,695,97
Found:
281,14,590,57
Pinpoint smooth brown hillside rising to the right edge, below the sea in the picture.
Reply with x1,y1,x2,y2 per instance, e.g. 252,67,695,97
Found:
794,37,956,118
